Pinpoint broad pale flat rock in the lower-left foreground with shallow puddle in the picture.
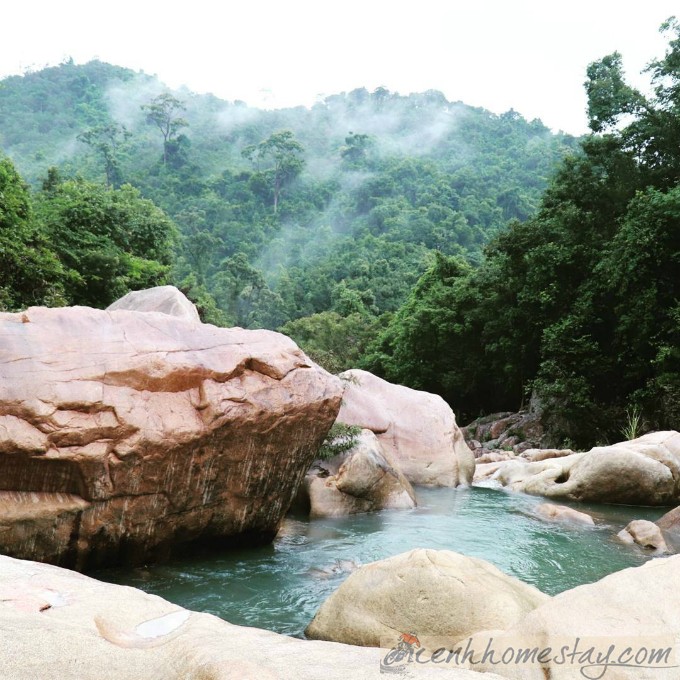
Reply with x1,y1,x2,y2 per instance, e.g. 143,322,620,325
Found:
0,556,500,680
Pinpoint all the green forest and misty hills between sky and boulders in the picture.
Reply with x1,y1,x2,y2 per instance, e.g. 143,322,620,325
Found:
0,19,680,443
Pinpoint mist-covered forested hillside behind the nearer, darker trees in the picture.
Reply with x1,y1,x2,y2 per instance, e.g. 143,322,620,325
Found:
0,62,576,348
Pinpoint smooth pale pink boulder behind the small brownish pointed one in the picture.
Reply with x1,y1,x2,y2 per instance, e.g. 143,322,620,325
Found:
338,369,475,486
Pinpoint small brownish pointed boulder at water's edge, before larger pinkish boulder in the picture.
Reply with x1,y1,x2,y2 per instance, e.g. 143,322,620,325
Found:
304,430,416,517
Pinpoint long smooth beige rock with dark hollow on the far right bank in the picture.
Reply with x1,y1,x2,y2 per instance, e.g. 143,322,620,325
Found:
475,431,680,505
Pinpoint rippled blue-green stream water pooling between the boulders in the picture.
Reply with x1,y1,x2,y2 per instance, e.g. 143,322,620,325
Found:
93,487,664,635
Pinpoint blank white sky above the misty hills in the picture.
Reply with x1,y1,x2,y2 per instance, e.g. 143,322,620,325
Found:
0,0,680,134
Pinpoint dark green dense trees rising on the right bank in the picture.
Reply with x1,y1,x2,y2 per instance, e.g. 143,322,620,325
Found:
365,20,680,446
